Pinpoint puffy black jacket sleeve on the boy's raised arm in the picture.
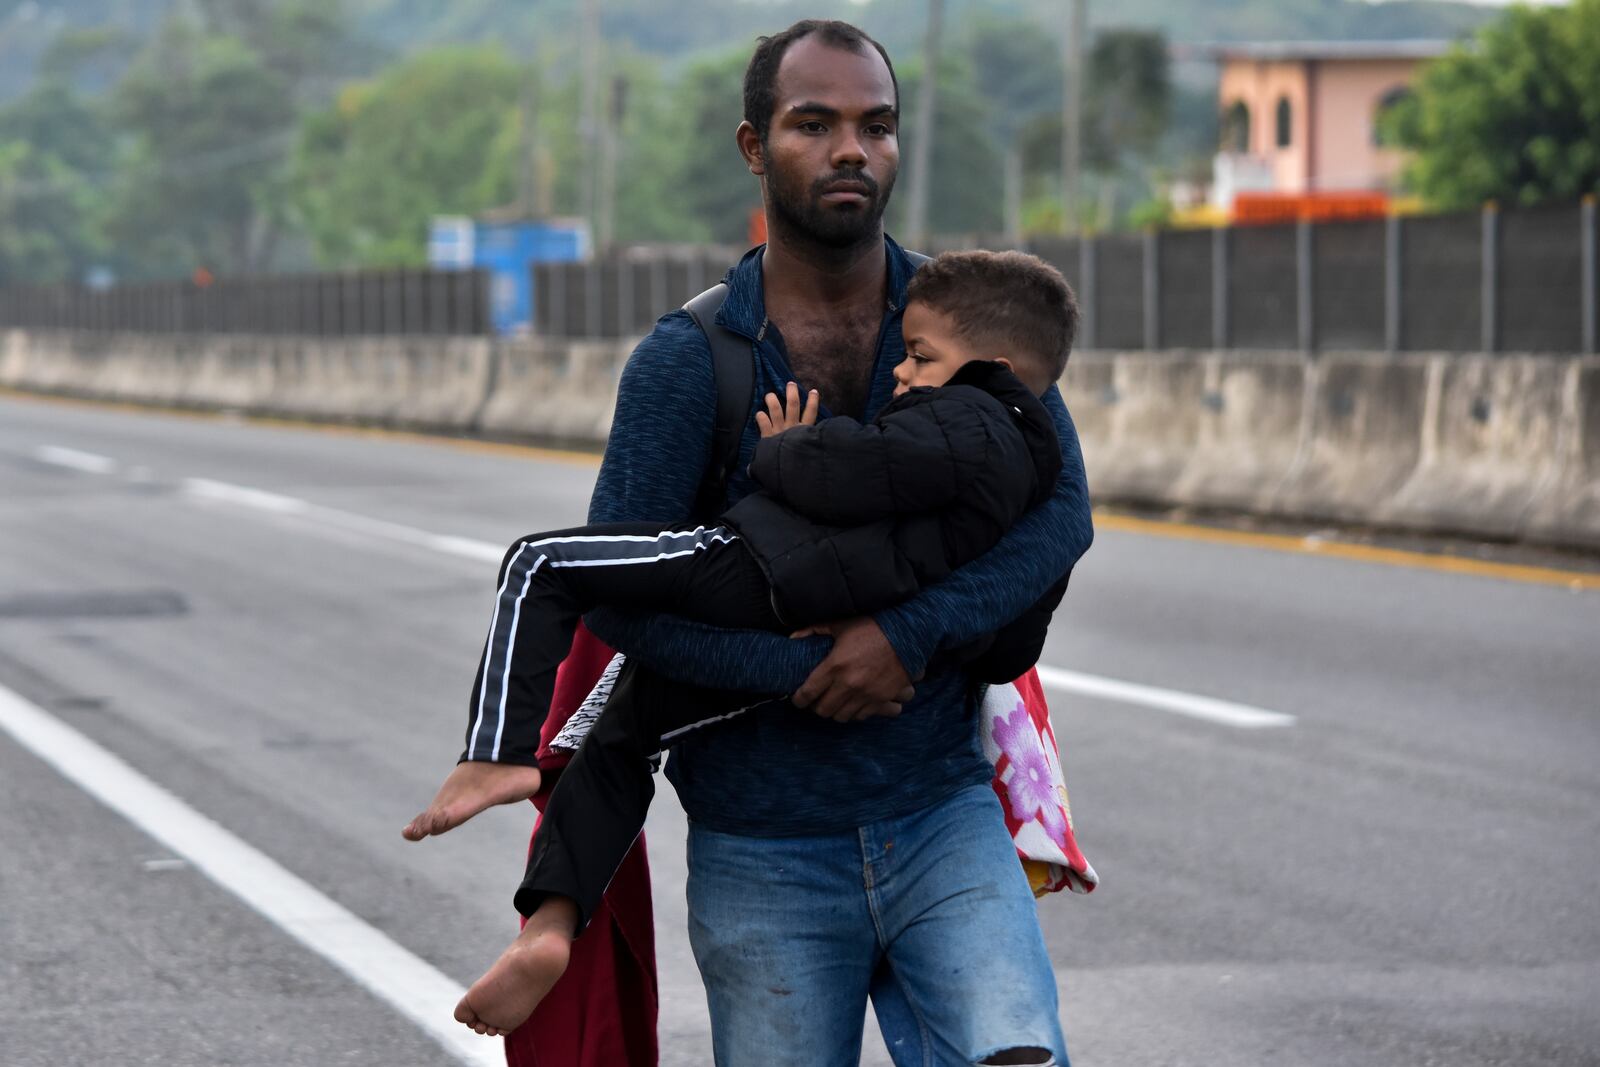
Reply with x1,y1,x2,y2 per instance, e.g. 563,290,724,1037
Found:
750,387,1006,526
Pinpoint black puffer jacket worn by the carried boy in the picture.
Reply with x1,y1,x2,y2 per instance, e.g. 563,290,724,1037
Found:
723,360,1061,627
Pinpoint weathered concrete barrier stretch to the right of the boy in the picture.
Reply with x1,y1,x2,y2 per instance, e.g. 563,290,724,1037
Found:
1064,352,1600,549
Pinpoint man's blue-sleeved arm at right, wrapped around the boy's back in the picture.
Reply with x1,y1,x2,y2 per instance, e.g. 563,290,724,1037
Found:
874,386,1094,678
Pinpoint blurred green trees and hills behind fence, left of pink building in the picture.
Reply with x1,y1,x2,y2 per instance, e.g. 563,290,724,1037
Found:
0,0,1510,280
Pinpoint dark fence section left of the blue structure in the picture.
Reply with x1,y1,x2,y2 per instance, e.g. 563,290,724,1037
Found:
0,270,490,336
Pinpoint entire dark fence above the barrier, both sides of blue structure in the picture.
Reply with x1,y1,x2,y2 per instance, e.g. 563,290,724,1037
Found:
0,198,1600,352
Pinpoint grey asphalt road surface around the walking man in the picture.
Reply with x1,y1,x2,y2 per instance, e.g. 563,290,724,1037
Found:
0,397,1600,1067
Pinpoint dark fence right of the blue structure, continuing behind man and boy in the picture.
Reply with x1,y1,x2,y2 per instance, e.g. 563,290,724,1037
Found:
521,200,1597,352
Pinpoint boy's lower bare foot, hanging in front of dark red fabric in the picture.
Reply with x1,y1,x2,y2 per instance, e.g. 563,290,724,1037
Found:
456,897,578,1037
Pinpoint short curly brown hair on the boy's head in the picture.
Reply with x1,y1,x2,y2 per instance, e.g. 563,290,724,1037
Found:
906,251,1078,392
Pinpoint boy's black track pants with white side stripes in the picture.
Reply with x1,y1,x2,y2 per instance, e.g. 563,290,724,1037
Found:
461,523,787,928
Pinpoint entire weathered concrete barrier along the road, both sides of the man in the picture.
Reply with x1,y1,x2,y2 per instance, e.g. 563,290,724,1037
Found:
0,331,1600,549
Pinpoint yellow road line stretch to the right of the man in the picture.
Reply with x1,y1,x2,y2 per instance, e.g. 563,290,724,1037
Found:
1094,512,1600,589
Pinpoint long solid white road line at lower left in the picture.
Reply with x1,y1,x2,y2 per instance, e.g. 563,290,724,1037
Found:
0,686,506,1067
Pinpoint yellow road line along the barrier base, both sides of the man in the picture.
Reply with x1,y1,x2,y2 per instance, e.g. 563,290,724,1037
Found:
0,386,1600,590
